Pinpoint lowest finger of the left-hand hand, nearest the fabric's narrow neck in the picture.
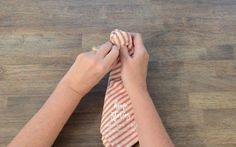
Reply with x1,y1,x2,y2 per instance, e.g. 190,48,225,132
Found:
104,45,119,68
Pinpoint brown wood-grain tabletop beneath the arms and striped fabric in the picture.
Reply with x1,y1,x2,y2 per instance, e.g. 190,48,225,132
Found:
0,0,236,147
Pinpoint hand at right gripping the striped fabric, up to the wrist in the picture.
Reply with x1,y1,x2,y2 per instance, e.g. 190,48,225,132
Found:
120,33,149,93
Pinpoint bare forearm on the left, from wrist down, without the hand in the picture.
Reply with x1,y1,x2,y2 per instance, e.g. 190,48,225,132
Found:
9,78,82,147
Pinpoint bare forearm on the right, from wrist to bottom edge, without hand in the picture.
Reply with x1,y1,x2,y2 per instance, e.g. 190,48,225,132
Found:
129,90,173,147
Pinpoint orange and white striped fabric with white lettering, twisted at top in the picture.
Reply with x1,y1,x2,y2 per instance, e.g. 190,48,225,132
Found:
100,29,138,147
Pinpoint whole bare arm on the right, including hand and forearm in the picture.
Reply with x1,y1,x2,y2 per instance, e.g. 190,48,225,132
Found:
120,33,174,147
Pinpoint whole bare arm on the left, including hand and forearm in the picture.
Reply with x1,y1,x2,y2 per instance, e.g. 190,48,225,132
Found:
9,42,119,147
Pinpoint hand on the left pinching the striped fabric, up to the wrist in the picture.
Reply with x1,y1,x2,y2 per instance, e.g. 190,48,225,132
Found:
62,42,119,96
